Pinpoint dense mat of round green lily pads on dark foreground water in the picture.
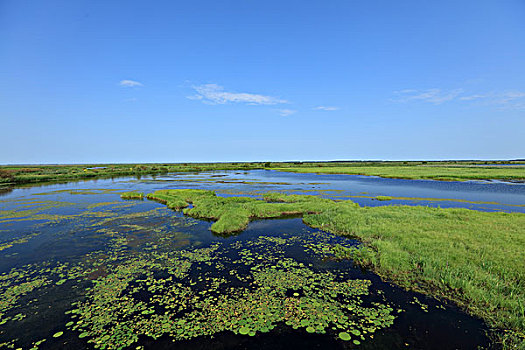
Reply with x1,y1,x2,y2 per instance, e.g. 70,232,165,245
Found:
63,237,394,348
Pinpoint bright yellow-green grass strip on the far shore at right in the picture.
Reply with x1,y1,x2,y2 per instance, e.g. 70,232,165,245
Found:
272,164,525,181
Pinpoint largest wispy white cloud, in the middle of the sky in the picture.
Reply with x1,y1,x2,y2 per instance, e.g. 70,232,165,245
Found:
188,84,288,105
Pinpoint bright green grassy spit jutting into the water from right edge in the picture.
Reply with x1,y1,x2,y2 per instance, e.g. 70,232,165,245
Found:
148,190,525,348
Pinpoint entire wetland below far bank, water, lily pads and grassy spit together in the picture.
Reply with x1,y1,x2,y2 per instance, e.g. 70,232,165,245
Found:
0,169,525,349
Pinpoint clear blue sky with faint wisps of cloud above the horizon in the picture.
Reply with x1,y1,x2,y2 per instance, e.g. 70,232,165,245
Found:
0,0,525,164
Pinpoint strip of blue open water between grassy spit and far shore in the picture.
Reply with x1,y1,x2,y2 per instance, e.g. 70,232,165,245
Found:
128,170,525,213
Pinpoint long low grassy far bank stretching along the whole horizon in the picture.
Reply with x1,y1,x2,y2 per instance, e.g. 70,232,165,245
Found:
0,161,525,186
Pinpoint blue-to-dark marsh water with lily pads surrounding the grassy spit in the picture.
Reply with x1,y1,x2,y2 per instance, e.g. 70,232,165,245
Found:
0,170,525,349
